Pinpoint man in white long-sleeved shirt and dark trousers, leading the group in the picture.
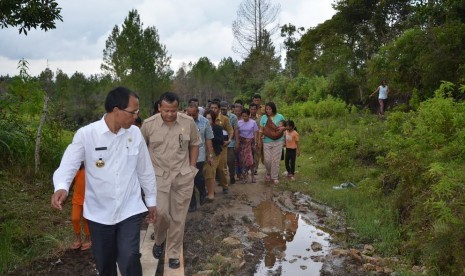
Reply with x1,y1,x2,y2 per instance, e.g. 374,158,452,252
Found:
51,87,157,276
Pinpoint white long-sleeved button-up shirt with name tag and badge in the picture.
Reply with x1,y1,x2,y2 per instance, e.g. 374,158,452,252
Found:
53,118,157,225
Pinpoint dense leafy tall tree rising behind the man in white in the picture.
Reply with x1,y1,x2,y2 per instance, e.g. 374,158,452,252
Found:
101,10,173,113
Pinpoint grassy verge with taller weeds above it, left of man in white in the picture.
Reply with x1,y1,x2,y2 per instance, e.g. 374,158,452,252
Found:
0,121,73,275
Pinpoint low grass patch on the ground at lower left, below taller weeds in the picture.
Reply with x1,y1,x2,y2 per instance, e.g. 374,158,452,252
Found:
0,171,73,275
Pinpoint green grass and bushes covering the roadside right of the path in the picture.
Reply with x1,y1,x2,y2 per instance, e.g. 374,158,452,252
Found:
281,89,465,275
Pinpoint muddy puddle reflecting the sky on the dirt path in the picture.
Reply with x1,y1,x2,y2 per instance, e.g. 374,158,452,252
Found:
254,201,330,275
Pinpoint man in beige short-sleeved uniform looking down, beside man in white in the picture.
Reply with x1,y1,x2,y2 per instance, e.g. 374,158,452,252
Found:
141,92,202,269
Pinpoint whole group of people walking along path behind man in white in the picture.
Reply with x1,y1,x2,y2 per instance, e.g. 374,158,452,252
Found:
51,87,300,275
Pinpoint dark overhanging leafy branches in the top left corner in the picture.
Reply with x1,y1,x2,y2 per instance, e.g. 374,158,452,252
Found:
0,0,63,35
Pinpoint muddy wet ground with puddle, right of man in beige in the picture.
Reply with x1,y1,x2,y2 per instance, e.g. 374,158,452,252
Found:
180,168,357,275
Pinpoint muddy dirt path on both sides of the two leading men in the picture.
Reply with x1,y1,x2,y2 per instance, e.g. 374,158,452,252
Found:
13,165,389,275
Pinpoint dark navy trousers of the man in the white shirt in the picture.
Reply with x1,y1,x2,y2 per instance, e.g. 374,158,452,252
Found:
88,214,142,276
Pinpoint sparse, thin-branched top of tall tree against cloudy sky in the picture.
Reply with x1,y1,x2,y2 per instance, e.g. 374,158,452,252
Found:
232,0,281,57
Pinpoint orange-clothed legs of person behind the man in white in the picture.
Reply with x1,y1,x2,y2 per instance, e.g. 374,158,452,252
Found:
71,163,92,250
